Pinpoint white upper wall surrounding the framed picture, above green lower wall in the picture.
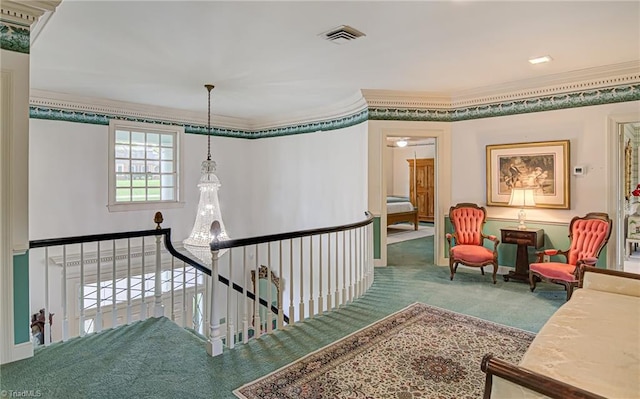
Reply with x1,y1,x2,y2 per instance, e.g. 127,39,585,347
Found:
451,101,640,222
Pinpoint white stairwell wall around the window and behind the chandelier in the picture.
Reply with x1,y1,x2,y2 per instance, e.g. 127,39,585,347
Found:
29,119,367,241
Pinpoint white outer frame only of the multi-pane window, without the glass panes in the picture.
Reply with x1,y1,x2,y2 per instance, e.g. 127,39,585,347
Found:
107,119,184,212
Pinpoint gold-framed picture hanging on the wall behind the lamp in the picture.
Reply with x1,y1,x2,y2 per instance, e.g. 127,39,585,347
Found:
487,140,570,209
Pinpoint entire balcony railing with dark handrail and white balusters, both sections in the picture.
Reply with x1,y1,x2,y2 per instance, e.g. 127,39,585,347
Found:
30,213,373,355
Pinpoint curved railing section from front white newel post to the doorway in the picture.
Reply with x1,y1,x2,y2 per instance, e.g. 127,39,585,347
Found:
206,212,374,356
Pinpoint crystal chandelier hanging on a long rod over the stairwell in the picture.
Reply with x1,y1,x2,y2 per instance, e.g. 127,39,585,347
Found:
182,84,229,263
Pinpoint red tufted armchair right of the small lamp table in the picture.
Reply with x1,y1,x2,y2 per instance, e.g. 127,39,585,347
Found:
529,212,612,301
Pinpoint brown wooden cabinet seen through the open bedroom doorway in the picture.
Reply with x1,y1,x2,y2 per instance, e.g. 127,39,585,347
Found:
407,158,435,222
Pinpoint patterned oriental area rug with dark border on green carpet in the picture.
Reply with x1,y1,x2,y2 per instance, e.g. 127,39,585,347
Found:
234,303,535,399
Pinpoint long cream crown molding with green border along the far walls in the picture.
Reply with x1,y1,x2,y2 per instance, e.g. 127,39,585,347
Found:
29,61,640,139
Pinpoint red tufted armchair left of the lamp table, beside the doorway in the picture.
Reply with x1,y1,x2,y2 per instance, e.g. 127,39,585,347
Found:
446,202,500,284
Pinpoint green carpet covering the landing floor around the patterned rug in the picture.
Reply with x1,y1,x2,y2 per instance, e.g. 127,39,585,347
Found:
0,237,565,399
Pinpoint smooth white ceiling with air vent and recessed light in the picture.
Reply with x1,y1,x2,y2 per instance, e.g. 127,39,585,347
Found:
30,0,640,122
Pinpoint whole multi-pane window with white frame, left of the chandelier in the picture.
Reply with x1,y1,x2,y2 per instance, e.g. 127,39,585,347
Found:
109,120,184,211
